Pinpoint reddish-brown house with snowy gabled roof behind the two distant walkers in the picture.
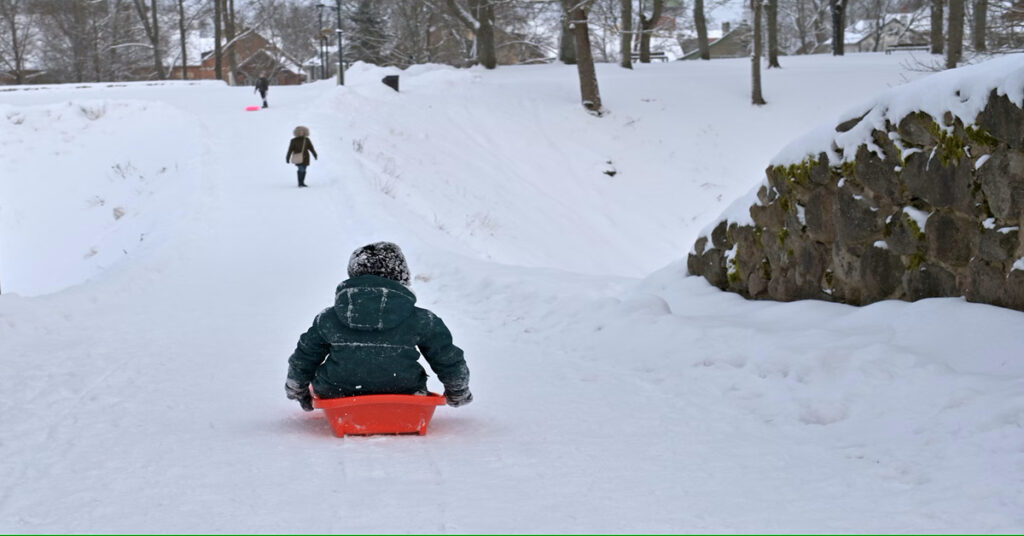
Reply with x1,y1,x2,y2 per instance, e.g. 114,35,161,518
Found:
168,31,306,85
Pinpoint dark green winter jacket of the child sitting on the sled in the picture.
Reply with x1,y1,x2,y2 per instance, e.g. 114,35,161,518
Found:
288,276,469,399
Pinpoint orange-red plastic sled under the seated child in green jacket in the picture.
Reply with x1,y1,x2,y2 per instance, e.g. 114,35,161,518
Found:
313,393,444,438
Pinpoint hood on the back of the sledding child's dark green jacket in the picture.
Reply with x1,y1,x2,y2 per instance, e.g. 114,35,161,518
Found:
334,276,416,331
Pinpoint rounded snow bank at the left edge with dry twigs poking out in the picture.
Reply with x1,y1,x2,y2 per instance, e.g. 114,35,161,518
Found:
0,99,201,295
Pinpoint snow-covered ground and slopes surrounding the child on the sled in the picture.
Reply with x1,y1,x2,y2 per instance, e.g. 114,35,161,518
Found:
6,54,1024,533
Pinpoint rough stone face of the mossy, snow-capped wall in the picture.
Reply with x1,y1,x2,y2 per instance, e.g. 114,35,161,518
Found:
687,84,1024,311
